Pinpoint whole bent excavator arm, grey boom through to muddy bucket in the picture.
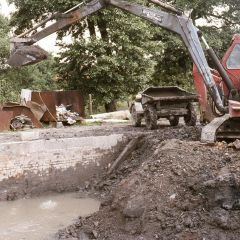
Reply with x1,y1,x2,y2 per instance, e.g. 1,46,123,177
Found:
9,0,228,113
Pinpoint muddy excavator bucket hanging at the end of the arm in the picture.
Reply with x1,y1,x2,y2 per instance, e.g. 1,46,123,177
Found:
8,45,48,67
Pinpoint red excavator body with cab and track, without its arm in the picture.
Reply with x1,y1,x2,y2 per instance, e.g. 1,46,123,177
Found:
193,35,240,142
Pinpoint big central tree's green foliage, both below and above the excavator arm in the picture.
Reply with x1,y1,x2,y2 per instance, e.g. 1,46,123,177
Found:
7,0,161,107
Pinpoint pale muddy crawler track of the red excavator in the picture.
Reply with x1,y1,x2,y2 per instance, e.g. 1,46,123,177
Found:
201,114,240,143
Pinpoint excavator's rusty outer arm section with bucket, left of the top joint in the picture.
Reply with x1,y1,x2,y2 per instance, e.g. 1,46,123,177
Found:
8,0,105,67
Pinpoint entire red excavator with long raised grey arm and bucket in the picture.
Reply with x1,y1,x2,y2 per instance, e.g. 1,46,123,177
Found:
6,0,240,143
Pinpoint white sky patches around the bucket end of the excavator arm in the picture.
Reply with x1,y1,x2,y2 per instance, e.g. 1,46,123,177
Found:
0,0,62,54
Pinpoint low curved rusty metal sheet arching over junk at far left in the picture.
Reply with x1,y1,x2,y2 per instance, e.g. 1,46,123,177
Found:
2,103,43,128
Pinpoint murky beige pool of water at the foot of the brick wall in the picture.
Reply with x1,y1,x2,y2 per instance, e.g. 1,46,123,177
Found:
0,193,100,240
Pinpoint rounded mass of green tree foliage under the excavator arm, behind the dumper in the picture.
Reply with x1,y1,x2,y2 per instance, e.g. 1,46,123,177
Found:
55,9,159,103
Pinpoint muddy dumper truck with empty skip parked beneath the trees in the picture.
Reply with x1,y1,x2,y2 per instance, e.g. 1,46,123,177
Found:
130,86,198,130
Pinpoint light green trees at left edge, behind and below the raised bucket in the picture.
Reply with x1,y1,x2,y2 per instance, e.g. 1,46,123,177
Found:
0,15,57,102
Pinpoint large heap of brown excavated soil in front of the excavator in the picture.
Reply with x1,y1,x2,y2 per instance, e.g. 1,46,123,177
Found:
57,127,240,240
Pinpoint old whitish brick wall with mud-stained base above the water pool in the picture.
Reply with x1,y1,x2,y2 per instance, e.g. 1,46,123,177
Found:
0,131,127,199
